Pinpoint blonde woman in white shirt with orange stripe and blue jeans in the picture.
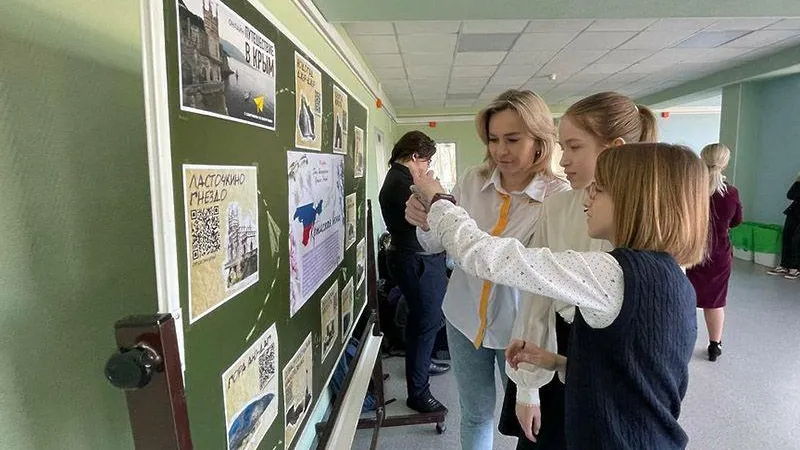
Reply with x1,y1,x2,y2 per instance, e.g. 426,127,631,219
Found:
406,90,569,450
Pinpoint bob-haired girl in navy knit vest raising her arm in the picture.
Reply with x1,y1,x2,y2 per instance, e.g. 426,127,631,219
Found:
406,144,708,450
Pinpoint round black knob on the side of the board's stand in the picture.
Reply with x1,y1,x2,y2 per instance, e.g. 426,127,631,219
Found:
105,342,163,390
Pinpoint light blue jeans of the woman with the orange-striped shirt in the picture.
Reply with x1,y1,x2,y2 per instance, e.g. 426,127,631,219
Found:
447,322,508,450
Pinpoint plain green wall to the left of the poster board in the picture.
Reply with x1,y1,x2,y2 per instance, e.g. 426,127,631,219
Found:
0,9,157,450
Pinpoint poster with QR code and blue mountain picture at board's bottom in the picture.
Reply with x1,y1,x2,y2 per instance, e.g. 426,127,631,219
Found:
222,324,279,450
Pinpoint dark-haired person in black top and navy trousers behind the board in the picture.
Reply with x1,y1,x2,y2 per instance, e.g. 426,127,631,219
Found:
378,131,450,413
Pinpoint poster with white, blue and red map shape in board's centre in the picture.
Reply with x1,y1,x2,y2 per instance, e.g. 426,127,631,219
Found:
287,152,345,317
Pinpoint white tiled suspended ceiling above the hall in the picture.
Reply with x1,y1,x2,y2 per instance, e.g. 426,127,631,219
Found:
343,18,800,110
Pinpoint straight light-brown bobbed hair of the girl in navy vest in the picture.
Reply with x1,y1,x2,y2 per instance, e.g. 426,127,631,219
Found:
595,143,709,267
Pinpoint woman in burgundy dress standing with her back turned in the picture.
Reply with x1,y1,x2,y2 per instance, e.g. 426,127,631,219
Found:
686,144,742,361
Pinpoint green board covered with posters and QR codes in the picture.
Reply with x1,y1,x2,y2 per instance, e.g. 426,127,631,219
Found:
164,0,369,450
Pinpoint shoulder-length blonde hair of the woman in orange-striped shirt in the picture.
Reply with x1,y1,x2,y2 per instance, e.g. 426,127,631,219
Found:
475,89,558,178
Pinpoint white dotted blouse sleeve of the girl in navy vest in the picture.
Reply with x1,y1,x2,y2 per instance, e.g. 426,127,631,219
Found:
428,197,624,328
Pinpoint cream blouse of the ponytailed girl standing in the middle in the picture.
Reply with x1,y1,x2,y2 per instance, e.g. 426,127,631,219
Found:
506,189,613,405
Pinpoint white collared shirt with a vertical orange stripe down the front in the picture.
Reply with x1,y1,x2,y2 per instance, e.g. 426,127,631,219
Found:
417,166,569,349
